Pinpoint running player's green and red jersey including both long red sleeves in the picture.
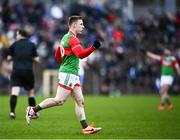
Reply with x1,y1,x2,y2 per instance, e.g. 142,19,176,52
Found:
55,32,94,75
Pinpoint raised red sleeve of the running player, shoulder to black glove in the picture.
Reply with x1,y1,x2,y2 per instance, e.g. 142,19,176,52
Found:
69,36,94,59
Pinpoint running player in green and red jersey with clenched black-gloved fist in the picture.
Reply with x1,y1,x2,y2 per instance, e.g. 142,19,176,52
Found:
26,16,101,134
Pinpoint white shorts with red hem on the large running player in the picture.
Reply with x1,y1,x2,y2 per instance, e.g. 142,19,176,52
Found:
59,72,81,91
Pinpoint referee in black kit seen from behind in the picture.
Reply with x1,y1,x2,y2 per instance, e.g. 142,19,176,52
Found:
7,29,39,119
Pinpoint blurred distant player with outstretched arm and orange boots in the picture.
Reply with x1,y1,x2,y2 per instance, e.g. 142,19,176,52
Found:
146,48,180,110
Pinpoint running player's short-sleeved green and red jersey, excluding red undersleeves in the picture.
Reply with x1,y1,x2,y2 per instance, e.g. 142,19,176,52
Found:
59,32,80,75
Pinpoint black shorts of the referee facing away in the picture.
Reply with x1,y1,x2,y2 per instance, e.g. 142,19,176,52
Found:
11,70,34,90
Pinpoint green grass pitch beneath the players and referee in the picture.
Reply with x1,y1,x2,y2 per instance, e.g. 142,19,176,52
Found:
0,96,180,139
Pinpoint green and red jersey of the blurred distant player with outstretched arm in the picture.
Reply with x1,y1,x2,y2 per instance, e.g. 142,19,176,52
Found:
161,56,178,76
